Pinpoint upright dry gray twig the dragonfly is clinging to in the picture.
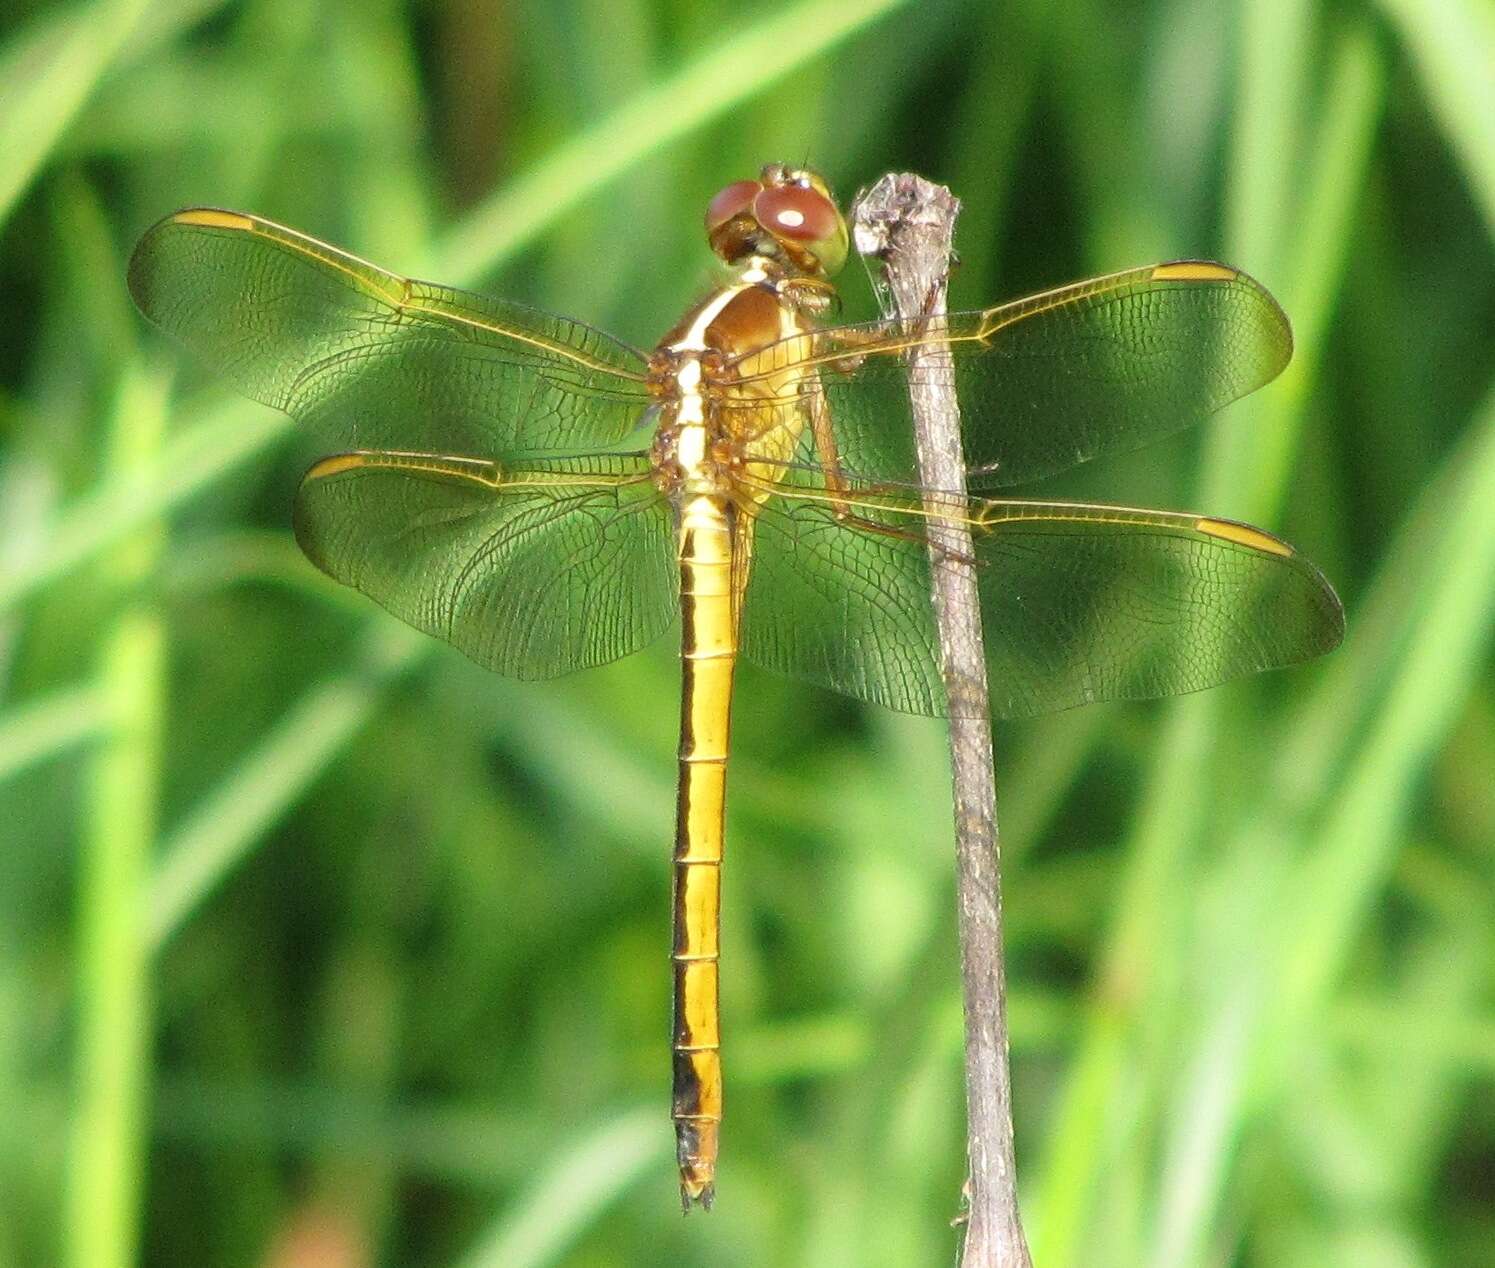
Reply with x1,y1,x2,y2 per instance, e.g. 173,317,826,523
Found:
852,173,1032,1268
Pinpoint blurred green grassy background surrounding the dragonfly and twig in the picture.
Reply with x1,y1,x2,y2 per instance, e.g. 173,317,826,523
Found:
0,0,1495,1268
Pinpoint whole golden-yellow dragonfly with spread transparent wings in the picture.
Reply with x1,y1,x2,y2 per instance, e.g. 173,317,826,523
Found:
129,164,1344,1210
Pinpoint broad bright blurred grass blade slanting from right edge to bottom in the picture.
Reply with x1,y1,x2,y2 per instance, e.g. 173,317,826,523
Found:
1150,376,1495,1265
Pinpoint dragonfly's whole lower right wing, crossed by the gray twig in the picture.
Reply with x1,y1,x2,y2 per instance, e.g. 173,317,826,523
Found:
743,498,1344,718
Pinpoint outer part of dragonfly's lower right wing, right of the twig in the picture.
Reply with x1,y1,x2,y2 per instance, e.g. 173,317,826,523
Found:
976,501,1344,718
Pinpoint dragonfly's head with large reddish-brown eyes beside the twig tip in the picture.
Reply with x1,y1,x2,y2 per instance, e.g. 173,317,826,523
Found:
706,163,848,277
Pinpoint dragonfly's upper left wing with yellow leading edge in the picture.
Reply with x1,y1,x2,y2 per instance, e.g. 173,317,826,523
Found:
130,208,647,458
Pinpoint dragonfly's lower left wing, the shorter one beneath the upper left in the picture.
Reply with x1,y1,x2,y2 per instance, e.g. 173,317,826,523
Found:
296,452,679,679
